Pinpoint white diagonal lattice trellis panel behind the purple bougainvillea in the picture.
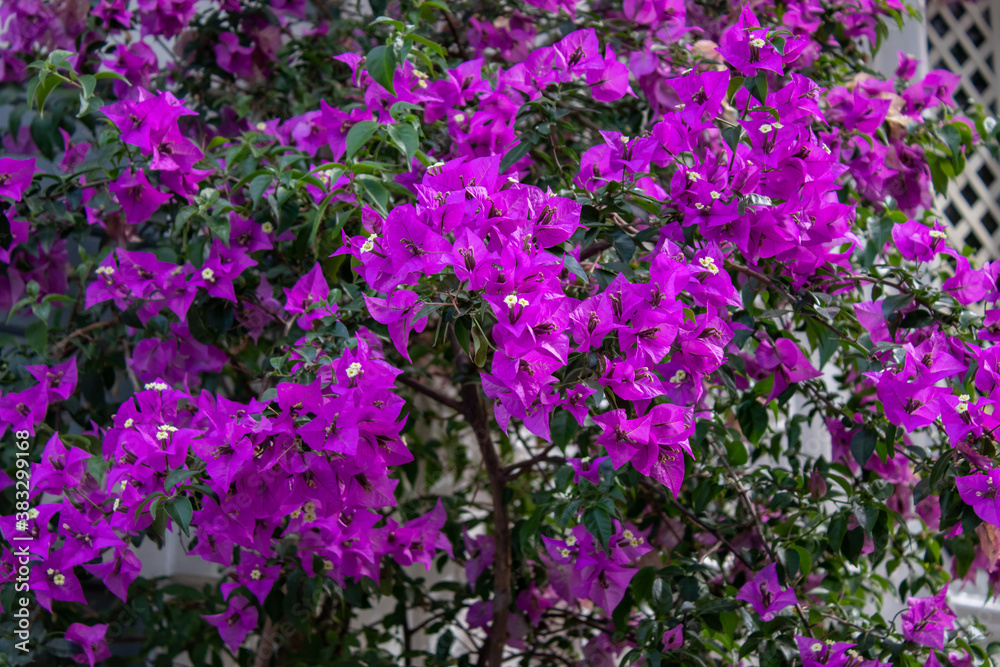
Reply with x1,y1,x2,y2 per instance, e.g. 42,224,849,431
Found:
925,0,1000,261
